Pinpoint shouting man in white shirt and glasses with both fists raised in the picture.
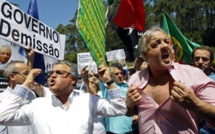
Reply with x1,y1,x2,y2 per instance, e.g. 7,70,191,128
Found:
0,61,127,134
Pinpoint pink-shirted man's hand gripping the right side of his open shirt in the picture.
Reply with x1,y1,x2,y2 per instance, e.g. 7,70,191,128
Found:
170,81,199,109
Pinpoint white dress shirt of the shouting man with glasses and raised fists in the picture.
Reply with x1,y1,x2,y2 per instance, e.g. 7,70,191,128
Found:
0,85,127,134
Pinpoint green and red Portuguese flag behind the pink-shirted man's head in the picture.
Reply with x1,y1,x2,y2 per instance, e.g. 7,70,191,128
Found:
163,10,200,64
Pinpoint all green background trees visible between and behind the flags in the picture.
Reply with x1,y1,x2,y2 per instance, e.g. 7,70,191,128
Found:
56,0,215,62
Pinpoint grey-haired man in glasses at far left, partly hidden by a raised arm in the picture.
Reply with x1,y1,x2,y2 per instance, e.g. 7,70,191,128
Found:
0,48,36,134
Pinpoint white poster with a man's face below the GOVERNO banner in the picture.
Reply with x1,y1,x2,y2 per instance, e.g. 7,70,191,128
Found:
0,39,27,70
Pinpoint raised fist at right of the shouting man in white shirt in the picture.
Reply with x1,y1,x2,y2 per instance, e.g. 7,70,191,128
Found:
98,65,112,83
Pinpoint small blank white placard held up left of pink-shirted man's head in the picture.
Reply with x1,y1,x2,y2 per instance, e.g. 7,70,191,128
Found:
106,49,126,62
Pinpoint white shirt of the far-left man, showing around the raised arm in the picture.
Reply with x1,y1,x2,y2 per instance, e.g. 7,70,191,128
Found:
0,86,36,134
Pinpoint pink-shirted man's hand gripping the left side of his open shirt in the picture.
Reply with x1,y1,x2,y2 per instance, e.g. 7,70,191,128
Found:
125,85,142,108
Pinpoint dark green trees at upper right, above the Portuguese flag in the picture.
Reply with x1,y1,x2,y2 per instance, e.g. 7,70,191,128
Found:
145,0,215,46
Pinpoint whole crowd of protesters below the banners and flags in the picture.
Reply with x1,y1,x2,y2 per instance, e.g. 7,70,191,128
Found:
0,0,215,134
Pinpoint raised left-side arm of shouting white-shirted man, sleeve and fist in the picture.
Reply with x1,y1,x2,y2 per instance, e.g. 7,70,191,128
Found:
0,69,41,125
